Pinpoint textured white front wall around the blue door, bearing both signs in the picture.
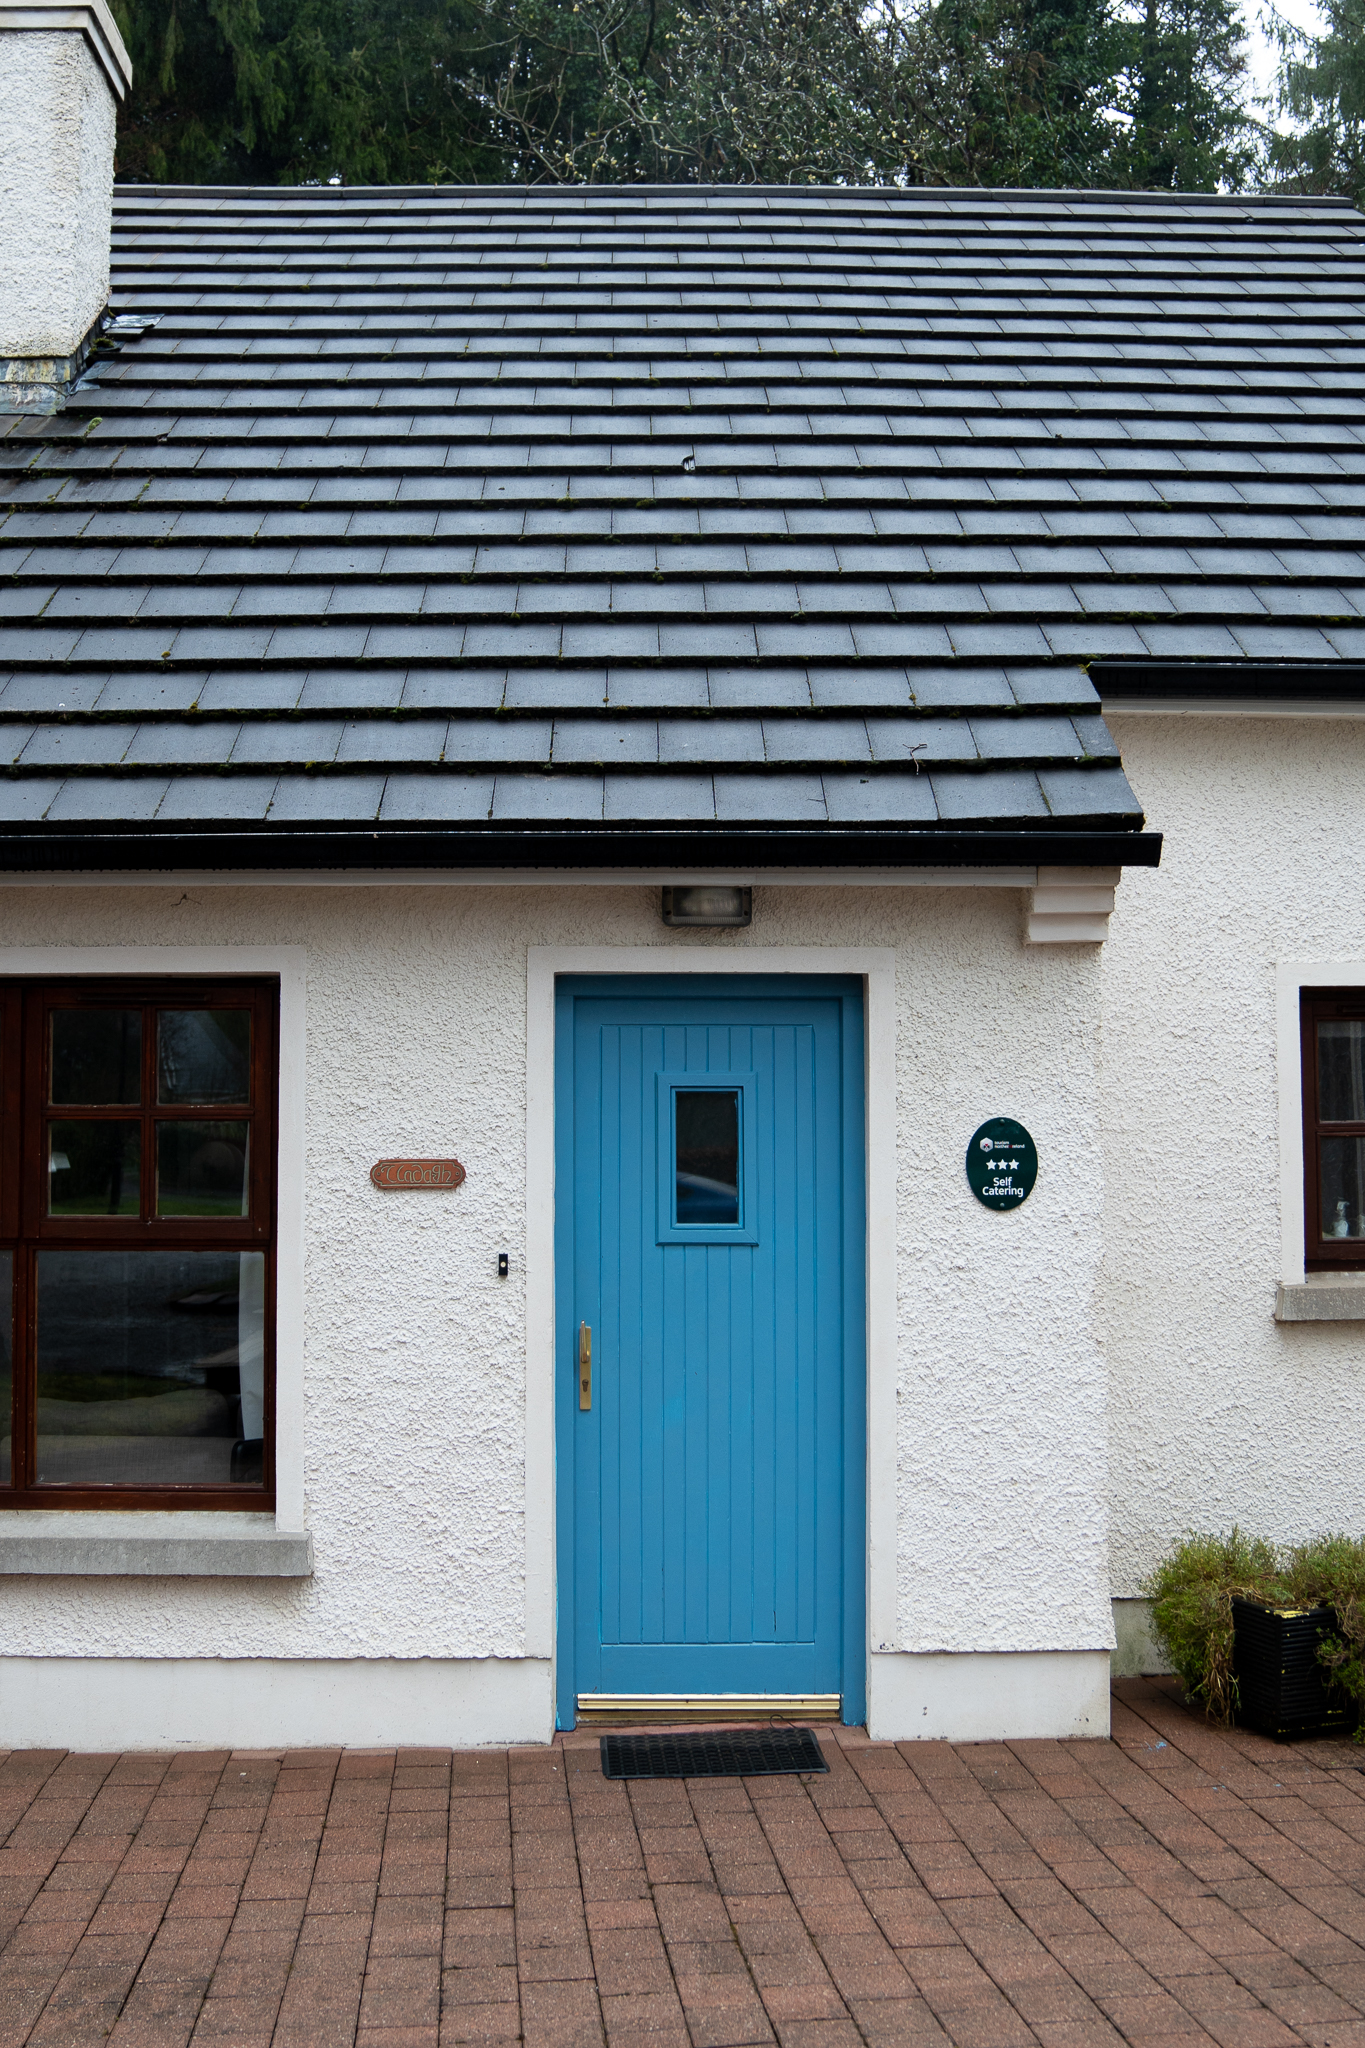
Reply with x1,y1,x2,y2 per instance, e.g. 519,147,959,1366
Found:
0,883,1121,1735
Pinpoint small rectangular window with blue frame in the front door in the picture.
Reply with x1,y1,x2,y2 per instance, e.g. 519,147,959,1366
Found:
657,1071,757,1245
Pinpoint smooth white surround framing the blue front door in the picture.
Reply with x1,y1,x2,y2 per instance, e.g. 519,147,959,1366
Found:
526,946,896,1710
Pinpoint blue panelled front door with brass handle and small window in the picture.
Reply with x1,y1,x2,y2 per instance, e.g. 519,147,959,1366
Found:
557,975,864,1726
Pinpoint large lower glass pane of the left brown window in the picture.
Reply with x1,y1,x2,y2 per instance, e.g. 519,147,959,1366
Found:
37,1251,266,1485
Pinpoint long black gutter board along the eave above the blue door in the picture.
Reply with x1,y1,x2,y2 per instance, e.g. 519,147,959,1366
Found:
0,825,1160,874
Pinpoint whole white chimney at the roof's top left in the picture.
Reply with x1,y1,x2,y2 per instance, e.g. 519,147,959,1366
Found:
0,0,133,412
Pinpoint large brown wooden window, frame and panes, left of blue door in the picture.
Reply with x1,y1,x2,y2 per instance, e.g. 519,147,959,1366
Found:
0,979,278,1509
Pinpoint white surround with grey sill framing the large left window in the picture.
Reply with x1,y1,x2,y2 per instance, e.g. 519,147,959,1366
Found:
0,946,311,1579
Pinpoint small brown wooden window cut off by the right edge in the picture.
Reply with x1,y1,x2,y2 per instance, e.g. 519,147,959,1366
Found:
1300,989,1365,1272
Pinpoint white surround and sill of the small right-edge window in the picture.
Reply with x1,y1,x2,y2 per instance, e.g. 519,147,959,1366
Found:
1275,961,1365,1323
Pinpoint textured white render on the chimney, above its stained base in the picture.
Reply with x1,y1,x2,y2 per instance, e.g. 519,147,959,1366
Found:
0,12,127,358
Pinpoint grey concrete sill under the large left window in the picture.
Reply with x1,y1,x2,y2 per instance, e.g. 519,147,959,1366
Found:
0,1507,313,1579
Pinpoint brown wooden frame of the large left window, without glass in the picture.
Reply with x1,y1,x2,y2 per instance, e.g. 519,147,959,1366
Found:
0,975,280,1513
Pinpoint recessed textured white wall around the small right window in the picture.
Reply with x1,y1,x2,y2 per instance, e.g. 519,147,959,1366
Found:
1101,713,1365,1595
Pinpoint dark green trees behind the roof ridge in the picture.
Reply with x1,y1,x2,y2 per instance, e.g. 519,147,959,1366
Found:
101,0,1285,190
